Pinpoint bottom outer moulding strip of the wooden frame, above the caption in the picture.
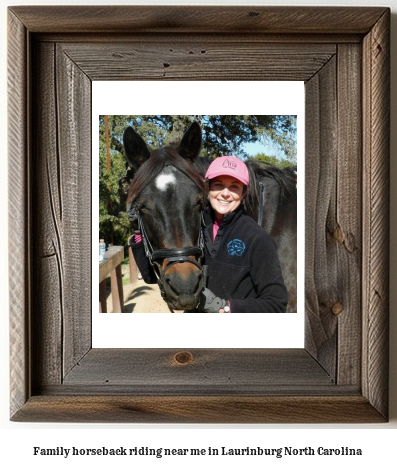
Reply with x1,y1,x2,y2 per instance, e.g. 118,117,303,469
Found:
13,394,385,424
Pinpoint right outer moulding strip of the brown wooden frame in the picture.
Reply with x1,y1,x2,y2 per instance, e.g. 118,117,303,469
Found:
362,11,390,414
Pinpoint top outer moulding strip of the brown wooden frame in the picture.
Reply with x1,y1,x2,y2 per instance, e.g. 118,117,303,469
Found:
8,5,384,34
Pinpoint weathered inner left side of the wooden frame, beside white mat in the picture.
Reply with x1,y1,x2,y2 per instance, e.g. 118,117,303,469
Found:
32,43,91,385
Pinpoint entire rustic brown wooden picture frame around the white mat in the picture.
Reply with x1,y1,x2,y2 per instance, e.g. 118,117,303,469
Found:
8,6,390,423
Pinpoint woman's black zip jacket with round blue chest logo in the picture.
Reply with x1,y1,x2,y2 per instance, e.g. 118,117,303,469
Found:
204,206,288,313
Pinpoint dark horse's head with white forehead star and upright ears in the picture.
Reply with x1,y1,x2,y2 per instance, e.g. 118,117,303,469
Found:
123,123,206,310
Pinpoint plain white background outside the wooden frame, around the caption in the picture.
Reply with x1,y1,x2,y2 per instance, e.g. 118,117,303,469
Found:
0,0,397,471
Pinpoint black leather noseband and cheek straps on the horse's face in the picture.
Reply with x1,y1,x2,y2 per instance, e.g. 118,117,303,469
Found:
128,164,204,312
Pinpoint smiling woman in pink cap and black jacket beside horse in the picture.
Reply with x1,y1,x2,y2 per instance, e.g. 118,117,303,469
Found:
203,156,288,313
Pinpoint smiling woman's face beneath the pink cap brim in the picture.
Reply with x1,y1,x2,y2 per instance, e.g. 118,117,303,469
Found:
209,175,245,219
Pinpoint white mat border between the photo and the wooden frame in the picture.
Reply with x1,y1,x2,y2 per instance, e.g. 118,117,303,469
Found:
92,81,305,348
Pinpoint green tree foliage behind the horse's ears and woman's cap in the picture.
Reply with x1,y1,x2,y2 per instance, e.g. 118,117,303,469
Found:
99,115,296,245
